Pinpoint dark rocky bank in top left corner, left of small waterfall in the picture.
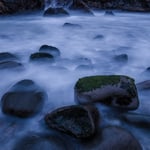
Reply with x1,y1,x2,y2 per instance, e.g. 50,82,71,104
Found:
0,0,44,15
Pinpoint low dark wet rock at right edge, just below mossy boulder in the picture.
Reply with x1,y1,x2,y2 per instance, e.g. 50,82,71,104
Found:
122,113,150,129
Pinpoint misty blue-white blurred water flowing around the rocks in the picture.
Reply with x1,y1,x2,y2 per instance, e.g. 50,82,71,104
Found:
0,12,150,150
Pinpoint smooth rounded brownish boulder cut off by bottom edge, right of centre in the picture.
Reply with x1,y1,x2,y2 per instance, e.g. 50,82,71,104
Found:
79,126,142,150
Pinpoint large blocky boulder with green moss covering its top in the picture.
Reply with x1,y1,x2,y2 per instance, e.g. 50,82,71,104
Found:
75,75,139,110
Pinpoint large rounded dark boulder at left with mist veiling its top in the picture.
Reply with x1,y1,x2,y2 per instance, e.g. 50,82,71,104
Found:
1,80,46,117
